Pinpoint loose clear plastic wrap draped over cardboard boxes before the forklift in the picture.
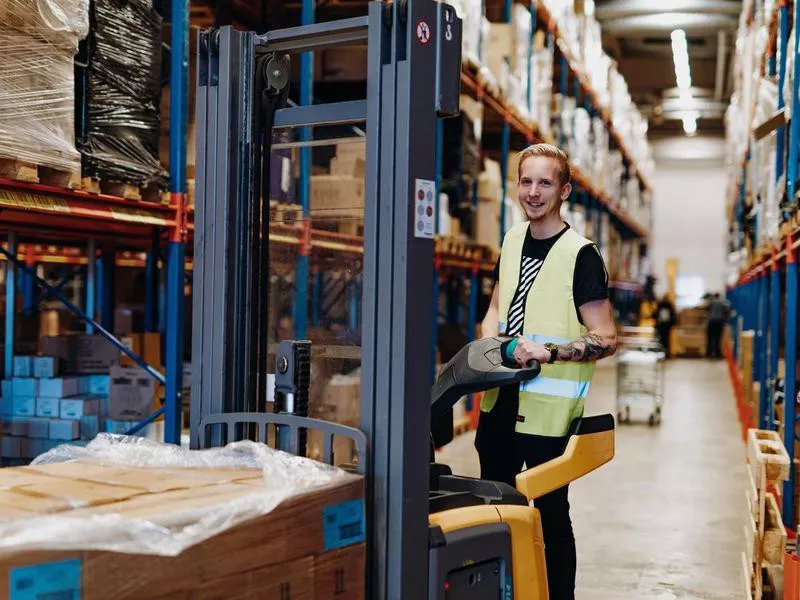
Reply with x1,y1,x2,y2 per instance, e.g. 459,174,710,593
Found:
0,434,356,556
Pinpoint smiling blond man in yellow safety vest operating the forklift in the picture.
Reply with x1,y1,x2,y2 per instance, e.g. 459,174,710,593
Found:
475,144,617,600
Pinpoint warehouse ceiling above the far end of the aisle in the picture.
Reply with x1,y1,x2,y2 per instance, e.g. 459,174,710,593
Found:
594,0,742,136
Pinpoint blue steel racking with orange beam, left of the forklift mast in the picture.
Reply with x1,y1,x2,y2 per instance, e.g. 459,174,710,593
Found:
0,0,189,444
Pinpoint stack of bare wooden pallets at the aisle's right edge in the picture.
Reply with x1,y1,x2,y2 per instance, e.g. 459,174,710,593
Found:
742,429,790,600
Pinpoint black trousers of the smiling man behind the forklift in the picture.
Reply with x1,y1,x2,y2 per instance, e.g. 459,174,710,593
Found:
475,393,577,600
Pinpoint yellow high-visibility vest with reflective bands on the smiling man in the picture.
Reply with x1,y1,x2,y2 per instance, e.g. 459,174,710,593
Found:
481,222,595,437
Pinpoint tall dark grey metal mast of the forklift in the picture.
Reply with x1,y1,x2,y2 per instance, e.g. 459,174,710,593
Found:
190,0,461,600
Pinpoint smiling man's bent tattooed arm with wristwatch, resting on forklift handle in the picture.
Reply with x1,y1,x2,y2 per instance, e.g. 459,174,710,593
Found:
514,300,617,365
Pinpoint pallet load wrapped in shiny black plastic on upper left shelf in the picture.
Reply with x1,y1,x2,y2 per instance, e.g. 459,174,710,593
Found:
81,0,166,188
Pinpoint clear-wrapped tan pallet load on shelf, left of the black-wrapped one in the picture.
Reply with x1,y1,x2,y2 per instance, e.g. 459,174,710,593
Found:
0,0,89,172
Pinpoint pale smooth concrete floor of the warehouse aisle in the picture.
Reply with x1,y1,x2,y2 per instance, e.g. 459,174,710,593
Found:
440,360,745,600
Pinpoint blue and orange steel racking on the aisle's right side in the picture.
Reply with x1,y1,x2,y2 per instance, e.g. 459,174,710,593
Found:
727,0,800,528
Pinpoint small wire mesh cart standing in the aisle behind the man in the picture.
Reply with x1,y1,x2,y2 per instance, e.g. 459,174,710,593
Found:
617,337,666,426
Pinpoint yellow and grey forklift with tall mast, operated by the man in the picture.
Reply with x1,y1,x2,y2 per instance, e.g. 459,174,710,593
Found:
190,0,614,600
